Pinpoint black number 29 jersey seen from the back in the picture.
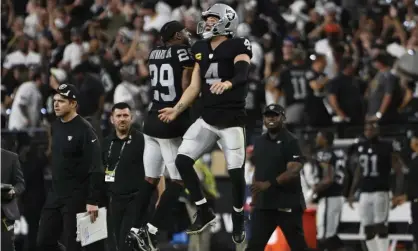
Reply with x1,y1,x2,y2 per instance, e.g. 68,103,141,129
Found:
144,45,194,139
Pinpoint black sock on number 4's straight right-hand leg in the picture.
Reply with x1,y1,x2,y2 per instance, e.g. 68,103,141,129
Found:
228,167,245,209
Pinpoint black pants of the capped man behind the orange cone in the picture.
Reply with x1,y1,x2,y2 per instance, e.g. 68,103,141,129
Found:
245,210,309,251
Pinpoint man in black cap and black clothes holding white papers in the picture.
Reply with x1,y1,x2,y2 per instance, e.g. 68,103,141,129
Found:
37,84,104,251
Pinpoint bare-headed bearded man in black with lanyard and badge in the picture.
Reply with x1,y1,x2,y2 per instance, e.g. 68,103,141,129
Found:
103,102,144,251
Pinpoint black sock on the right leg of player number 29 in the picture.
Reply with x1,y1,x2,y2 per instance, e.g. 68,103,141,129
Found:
150,182,184,229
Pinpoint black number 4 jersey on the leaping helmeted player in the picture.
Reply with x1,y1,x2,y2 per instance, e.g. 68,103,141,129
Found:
192,38,252,127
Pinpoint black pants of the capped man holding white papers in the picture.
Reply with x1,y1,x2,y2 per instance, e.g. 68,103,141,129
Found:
37,191,104,251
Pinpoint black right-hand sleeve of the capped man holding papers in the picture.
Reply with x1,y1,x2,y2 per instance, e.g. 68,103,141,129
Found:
83,128,104,205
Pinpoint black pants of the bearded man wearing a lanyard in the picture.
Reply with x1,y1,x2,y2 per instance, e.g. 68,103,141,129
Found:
110,193,136,251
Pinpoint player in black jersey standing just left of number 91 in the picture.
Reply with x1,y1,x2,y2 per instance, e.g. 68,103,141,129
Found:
313,131,346,251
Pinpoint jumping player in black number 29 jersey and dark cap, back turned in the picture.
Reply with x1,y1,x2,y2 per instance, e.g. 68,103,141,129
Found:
127,21,194,251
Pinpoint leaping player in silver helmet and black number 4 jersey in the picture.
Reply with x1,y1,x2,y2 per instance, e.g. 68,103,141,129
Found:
160,4,252,243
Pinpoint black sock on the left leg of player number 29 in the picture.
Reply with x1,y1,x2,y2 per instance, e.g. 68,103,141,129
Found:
134,180,157,228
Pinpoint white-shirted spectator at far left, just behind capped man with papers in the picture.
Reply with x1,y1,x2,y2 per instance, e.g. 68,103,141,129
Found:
8,66,42,130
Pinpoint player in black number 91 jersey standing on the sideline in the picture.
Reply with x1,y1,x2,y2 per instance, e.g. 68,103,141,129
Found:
348,123,403,251
